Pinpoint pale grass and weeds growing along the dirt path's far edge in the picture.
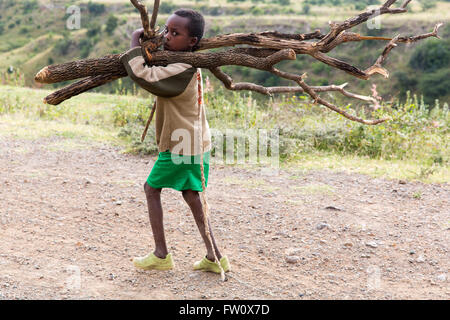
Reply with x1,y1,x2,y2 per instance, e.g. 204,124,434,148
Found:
0,82,450,181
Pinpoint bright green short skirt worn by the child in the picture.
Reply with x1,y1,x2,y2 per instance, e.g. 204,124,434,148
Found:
147,150,210,192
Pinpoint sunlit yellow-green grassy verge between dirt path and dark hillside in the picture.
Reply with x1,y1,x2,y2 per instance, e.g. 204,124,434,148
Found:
0,86,450,183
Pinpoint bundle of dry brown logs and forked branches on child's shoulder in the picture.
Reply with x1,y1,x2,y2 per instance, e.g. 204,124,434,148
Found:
35,0,442,124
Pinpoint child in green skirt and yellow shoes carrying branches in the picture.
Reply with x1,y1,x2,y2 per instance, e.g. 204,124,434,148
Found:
120,9,230,273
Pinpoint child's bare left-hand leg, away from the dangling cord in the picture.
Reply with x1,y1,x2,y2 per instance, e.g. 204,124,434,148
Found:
144,182,168,259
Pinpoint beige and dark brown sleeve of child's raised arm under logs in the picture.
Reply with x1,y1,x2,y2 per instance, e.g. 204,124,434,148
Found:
120,47,197,98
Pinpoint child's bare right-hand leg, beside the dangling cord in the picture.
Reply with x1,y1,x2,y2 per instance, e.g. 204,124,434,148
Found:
182,190,222,261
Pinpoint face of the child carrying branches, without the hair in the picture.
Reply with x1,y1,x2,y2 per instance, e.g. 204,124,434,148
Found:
164,14,197,51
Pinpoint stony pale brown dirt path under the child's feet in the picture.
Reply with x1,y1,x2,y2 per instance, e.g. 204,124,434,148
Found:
0,138,450,299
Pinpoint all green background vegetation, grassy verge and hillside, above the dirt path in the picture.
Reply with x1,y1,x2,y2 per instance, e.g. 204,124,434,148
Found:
0,0,450,182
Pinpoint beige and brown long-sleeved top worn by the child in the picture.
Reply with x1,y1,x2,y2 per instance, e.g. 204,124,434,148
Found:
120,47,211,155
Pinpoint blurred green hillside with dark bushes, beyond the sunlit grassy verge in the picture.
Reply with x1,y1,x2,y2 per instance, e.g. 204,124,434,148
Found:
0,0,450,104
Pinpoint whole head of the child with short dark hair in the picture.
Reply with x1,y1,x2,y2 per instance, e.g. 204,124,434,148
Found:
164,9,205,51
